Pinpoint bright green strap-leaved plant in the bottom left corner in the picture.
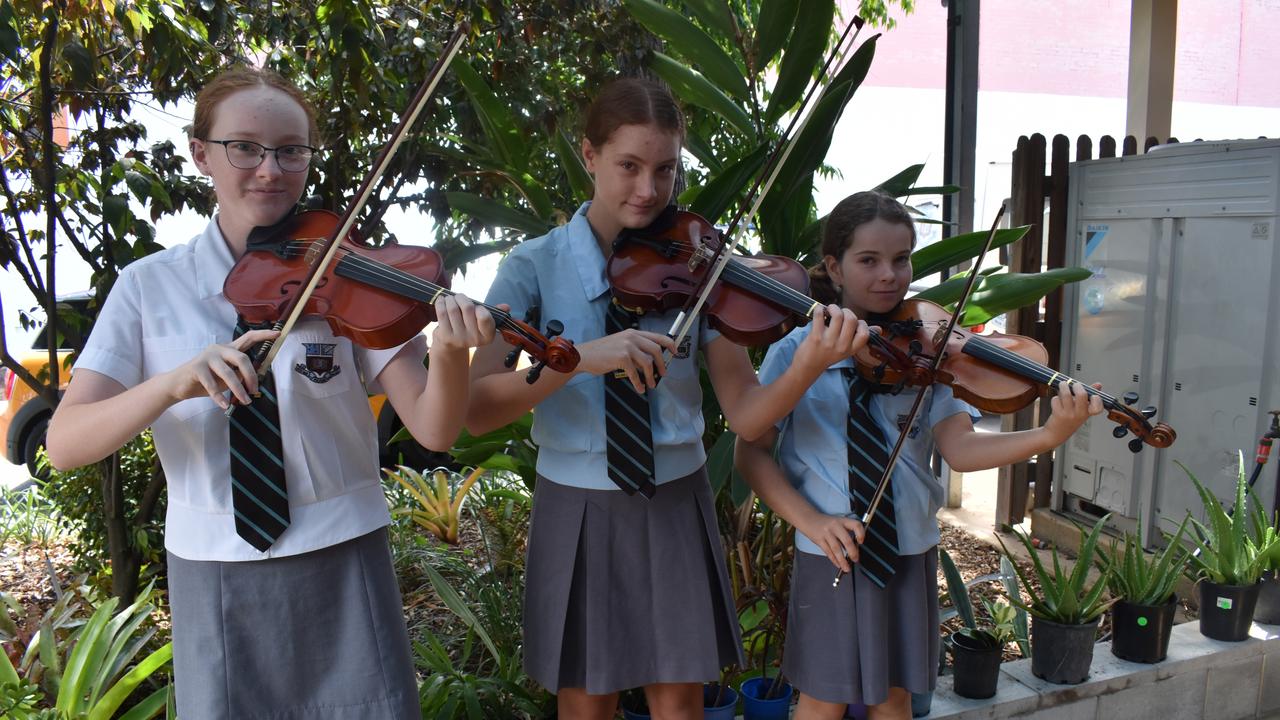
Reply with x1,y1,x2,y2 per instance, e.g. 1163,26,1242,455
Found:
0,576,173,720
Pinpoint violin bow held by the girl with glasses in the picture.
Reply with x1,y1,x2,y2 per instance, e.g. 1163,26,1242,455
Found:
240,22,470,381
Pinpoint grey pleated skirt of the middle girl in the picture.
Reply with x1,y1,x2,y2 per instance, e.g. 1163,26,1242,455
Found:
525,469,744,694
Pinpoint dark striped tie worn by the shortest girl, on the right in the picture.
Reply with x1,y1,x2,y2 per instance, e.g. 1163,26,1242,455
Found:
844,368,899,588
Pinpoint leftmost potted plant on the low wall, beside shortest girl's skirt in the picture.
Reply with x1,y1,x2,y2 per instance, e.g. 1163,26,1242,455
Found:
938,550,1016,700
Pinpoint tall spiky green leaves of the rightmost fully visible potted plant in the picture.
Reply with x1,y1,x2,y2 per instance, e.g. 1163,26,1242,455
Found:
1175,454,1280,585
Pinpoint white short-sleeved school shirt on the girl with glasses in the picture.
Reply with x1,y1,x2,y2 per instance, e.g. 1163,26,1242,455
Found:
76,218,426,561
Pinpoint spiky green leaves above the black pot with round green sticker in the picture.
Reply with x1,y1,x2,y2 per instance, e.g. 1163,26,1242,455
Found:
1097,520,1188,605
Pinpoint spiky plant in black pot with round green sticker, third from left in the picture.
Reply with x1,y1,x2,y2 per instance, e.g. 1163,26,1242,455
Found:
1098,520,1187,662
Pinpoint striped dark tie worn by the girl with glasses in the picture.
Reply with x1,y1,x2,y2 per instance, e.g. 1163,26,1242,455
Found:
230,318,289,551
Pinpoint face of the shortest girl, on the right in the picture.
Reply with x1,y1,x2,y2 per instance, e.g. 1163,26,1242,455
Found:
823,218,911,315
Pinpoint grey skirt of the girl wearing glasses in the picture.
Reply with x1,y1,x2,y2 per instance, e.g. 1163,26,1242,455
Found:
169,528,421,720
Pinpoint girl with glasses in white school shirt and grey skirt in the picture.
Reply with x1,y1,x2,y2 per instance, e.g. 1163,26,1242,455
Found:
47,68,493,720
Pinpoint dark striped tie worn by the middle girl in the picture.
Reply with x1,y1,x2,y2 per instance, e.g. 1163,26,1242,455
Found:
604,302,658,497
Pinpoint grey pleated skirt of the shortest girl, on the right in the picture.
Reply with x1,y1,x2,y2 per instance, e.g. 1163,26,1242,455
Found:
782,547,941,705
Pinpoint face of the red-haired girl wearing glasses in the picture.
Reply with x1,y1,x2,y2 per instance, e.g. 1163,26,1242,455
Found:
191,86,311,247
